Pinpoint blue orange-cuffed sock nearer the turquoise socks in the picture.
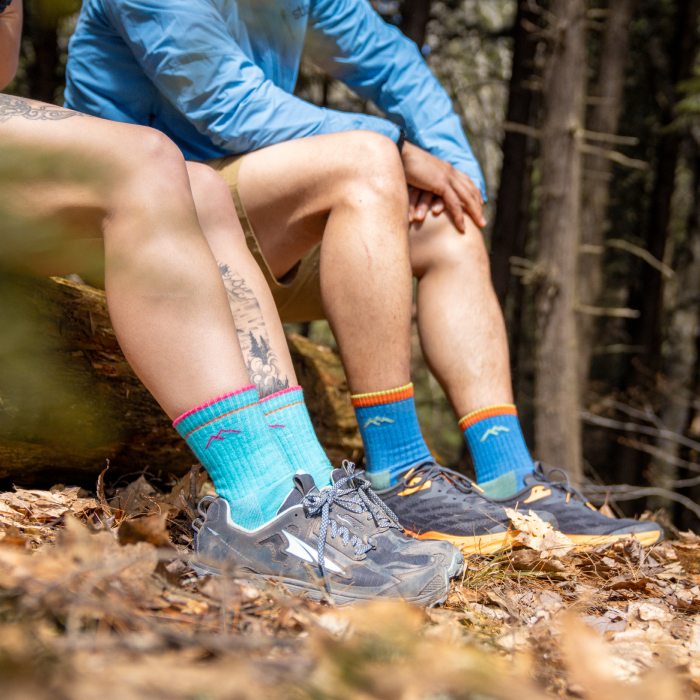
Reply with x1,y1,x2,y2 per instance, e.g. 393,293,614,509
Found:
351,384,432,489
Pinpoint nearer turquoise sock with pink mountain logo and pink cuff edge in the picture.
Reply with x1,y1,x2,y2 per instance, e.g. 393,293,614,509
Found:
173,386,294,530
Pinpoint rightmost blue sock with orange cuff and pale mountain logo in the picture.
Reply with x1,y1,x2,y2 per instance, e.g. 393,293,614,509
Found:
459,404,534,491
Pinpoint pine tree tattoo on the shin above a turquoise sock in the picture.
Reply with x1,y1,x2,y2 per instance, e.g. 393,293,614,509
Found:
219,263,289,397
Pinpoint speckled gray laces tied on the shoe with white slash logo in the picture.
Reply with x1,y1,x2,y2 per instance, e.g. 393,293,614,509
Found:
301,462,382,593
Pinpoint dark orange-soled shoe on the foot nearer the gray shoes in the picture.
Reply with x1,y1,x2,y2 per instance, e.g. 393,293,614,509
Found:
376,462,518,554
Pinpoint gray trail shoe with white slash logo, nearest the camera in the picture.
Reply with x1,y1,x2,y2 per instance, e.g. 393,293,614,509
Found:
193,474,450,606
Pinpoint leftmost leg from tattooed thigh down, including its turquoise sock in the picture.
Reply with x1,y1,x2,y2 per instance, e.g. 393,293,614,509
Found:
0,96,293,527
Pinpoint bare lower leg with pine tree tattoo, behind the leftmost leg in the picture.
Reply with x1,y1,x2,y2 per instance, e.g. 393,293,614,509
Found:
187,163,298,397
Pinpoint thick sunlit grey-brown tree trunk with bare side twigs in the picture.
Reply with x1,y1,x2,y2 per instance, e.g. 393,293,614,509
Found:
535,0,586,480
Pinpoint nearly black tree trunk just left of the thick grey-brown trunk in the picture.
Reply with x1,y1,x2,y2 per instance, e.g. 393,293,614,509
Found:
491,0,538,305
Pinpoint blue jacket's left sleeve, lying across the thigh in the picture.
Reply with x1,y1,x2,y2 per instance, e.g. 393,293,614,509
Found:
105,0,399,153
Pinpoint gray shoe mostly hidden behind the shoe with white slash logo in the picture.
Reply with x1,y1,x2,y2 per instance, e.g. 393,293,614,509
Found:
331,461,464,578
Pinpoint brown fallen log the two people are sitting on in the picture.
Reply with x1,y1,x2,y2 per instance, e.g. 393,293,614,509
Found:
0,278,362,486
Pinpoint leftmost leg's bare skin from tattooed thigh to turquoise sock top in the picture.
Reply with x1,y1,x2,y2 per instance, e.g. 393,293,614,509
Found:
0,95,248,417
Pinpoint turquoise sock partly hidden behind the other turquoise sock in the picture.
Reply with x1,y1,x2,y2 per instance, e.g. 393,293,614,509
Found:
260,386,333,488
